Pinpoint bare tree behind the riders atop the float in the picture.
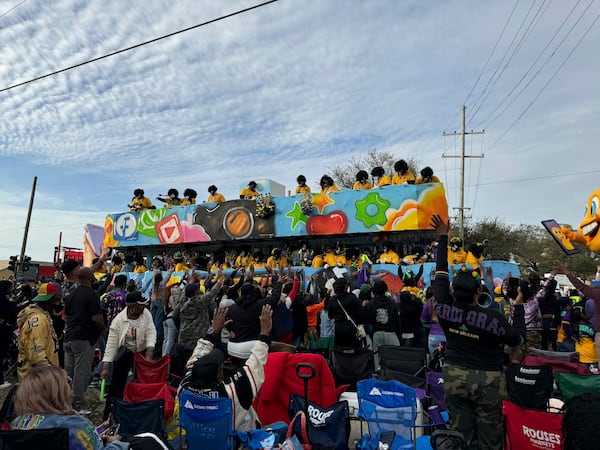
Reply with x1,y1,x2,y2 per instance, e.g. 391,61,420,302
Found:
329,148,418,189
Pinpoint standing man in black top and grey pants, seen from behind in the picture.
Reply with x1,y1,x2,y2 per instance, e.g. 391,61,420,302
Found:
64,267,105,414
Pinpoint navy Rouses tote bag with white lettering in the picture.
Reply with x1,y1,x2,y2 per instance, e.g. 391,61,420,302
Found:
288,394,350,450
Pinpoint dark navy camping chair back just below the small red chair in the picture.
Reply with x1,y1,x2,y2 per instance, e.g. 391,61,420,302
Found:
111,398,165,436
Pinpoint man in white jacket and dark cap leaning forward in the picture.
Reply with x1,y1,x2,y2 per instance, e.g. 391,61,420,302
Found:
100,291,156,419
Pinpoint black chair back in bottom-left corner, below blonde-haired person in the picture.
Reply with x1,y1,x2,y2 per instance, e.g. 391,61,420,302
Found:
0,428,69,450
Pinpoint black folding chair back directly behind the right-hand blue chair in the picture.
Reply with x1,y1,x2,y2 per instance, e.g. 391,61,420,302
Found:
377,345,427,389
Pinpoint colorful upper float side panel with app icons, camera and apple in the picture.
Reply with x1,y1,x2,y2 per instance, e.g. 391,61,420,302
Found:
104,183,448,248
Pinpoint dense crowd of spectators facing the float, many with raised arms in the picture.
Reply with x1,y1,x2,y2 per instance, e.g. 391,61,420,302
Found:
0,229,600,448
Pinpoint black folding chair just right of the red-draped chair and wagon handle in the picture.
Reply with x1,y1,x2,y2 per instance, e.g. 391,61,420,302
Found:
331,347,374,390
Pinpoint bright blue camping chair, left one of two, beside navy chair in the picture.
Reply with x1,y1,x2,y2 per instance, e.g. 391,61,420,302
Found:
179,390,234,450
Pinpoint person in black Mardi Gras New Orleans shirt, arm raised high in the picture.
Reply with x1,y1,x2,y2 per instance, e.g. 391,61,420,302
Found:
431,215,525,450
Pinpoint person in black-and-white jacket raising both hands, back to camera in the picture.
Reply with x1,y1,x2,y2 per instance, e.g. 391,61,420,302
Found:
180,305,273,431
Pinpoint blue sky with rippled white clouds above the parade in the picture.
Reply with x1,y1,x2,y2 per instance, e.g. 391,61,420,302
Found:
0,0,600,260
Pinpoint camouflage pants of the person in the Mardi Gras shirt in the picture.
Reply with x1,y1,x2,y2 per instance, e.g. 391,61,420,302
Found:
444,364,506,450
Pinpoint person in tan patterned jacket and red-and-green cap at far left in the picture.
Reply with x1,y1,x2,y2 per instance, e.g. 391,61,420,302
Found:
17,283,63,381
